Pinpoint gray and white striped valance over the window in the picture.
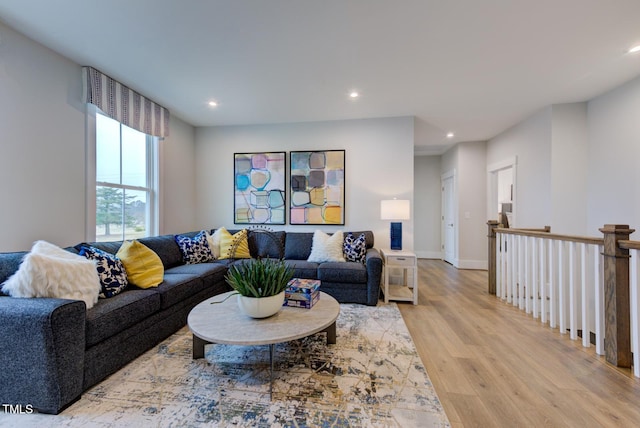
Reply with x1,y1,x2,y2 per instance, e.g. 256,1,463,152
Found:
82,67,169,137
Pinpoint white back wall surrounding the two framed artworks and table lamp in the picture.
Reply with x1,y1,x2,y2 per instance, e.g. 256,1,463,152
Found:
196,117,415,249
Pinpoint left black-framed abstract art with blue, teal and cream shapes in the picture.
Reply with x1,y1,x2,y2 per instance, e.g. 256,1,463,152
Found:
233,152,287,224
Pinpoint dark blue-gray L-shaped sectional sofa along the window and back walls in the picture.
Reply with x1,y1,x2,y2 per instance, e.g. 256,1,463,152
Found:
0,230,382,413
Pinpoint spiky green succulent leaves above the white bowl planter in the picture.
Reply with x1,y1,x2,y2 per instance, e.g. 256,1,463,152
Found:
225,259,293,297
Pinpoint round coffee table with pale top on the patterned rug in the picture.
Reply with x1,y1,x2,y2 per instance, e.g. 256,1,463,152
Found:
187,291,340,393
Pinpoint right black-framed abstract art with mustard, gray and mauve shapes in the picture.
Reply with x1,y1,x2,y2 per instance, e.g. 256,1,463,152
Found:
289,150,345,225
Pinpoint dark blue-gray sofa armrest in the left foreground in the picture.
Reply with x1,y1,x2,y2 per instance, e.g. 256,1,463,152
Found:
0,297,86,413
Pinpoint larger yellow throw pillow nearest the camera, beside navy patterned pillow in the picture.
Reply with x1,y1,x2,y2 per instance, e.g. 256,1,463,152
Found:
116,240,164,288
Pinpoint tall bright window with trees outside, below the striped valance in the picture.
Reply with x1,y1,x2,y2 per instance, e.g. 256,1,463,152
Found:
95,113,158,241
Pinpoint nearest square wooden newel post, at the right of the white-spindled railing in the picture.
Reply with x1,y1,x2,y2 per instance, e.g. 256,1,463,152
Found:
600,224,634,367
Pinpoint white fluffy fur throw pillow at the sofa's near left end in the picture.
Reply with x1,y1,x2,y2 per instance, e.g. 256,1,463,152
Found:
2,241,101,309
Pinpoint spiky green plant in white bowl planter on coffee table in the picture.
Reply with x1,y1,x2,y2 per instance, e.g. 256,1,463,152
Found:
225,259,293,318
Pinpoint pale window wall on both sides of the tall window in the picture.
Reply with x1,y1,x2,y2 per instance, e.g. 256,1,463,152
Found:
0,23,196,251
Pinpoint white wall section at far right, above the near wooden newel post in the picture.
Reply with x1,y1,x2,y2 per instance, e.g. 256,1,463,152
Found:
587,78,640,239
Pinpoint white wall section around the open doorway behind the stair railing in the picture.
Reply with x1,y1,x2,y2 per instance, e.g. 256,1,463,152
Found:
485,107,554,230
